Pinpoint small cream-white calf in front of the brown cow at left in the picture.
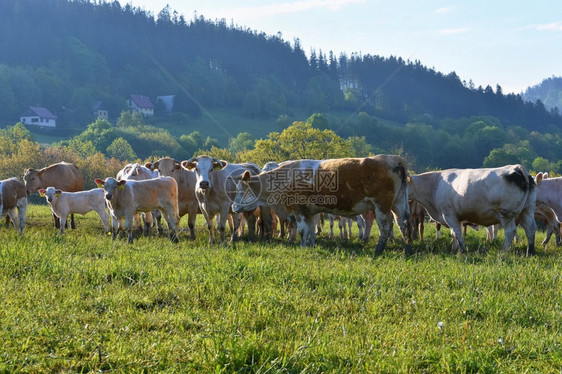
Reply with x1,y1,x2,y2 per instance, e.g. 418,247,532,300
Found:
39,187,109,234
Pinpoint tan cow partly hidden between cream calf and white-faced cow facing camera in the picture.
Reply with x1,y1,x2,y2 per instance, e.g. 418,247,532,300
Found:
145,157,199,240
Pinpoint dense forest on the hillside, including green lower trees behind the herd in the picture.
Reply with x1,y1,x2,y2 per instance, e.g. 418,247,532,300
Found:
0,0,562,173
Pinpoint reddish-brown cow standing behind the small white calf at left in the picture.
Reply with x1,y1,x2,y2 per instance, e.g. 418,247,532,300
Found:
23,162,84,229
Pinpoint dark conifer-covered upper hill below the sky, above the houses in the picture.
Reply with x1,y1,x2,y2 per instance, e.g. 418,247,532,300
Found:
0,0,562,129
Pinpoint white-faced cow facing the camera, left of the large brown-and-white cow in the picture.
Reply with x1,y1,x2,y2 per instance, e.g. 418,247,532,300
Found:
181,155,261,244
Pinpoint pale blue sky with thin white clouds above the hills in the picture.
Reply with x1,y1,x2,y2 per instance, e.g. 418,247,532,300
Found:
127,0,562,94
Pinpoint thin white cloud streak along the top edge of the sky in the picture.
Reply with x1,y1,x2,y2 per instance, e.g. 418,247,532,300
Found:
212,0,365,19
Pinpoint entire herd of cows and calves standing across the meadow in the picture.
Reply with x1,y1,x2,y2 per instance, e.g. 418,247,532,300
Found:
0,155,562,255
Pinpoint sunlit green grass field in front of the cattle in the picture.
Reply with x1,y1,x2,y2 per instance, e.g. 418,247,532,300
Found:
0,205,562,373
